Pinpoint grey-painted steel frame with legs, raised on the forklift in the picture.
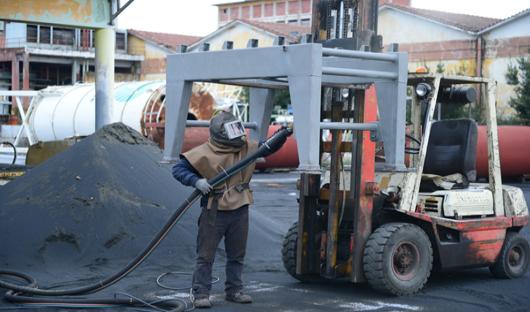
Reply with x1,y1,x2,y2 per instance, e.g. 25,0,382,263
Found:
164,43,407,174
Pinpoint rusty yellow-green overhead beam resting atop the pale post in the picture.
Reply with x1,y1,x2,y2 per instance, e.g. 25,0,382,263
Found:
0,0,111,28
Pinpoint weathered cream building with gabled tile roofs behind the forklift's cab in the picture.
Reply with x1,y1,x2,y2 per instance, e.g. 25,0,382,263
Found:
378,4,530,120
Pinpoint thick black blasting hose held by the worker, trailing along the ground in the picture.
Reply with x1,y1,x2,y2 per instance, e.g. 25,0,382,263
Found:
0,128,292,302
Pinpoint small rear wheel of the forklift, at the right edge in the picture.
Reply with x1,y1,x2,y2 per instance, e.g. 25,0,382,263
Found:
490,232,530,279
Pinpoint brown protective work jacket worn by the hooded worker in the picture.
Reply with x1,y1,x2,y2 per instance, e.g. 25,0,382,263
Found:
182,139,258,211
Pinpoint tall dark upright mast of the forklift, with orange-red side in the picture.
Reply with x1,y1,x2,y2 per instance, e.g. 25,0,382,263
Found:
290,0,382,282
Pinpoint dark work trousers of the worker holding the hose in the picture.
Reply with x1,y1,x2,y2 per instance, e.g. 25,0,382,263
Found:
193,205,248,297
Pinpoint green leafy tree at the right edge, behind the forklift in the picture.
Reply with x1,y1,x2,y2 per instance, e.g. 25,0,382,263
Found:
505,51,530,125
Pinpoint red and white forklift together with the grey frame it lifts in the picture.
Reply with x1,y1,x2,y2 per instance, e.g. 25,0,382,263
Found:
163,0,530,295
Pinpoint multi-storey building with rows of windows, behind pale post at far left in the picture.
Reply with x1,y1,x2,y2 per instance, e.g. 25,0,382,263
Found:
0,22,143,90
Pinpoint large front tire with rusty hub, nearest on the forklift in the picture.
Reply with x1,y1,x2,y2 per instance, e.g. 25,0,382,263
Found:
363,223,433,296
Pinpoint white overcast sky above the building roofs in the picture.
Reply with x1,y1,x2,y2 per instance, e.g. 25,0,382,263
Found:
118,0,530,36
